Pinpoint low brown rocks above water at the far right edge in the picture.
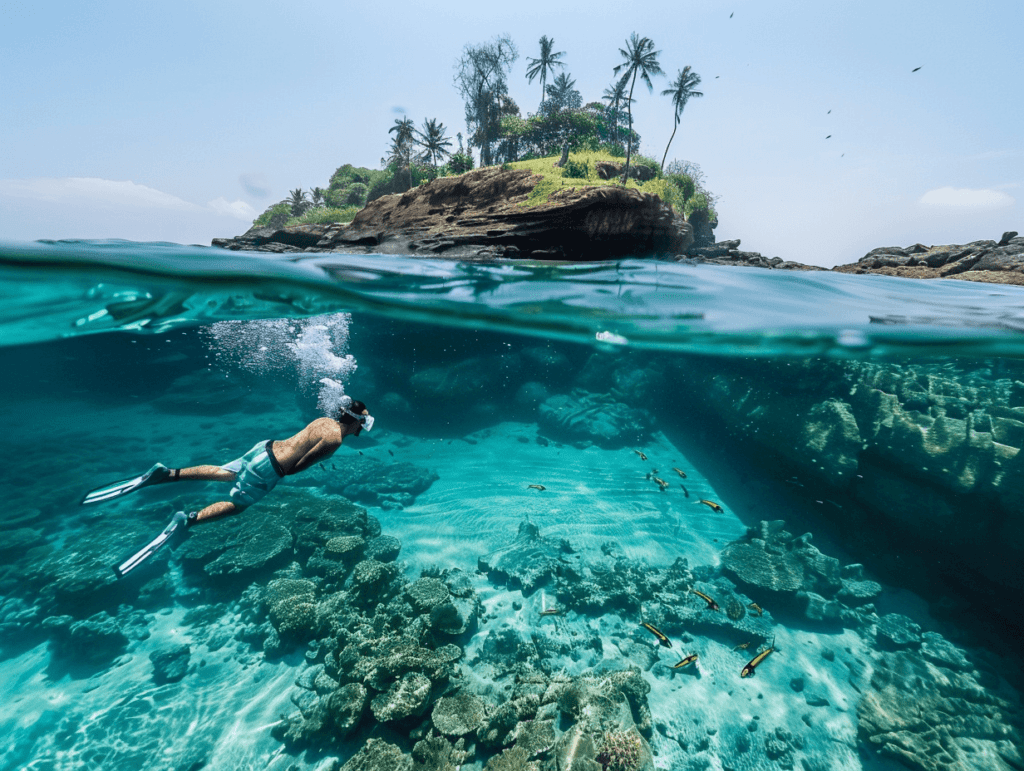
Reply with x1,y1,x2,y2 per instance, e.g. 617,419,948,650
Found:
833,230,1024,285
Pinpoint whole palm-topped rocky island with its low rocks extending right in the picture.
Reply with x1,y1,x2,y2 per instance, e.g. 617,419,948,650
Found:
213,34,1024,285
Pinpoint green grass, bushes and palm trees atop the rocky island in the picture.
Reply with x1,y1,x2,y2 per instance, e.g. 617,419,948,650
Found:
253,33,717,228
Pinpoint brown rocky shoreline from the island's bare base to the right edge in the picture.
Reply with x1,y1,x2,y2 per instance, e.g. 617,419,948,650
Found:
213,167,1024,286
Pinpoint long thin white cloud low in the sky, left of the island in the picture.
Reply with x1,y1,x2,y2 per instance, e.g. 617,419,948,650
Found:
0,177,257,220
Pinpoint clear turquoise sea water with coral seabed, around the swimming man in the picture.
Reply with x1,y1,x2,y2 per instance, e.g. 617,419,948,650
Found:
0,242,1024,771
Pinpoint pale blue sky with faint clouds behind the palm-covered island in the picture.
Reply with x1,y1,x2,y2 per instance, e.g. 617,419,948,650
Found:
0,0,1024,265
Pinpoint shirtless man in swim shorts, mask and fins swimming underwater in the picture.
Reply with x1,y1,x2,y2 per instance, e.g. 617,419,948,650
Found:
82,397,374,579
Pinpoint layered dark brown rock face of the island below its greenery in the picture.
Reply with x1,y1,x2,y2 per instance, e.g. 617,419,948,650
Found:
213,167,692,260
